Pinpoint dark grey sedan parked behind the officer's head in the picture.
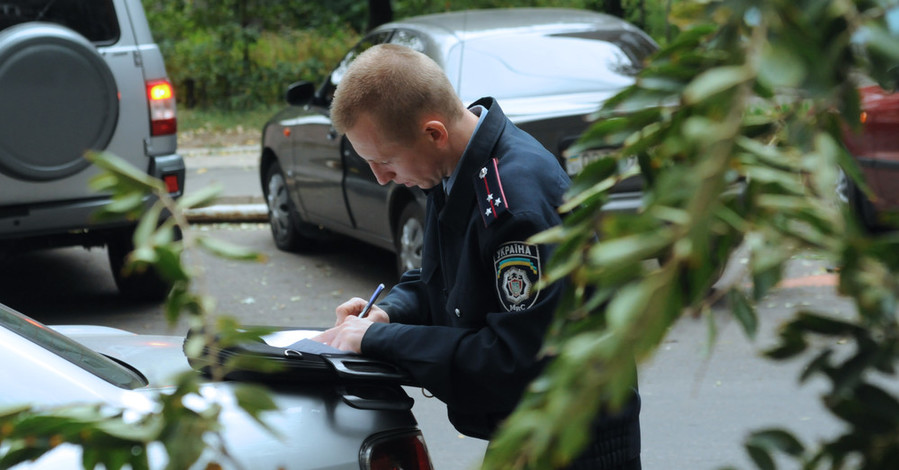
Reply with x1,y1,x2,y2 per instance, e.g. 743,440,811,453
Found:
259,8,657,272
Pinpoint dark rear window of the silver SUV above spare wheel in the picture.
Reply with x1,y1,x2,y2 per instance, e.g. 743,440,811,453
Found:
0,0,120,44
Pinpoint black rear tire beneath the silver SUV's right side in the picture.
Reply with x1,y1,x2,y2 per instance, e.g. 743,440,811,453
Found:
106,228,181,302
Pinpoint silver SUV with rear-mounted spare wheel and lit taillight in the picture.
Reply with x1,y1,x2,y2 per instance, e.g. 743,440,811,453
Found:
0,0,184,298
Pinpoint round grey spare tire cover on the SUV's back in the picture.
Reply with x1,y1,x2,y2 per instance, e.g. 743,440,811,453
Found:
0,23,119,181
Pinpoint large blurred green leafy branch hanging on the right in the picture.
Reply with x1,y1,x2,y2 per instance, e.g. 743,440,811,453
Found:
485,0,899,470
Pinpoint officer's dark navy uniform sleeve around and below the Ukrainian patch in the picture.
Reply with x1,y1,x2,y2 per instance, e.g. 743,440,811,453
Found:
362,214,563,415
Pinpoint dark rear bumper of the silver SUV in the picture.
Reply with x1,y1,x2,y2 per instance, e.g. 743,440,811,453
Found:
0,154,185,248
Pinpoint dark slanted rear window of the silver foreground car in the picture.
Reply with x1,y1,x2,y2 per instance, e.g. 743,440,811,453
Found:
0,304,146,390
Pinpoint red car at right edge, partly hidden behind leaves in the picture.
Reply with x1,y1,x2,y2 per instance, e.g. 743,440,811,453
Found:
838,84,899,231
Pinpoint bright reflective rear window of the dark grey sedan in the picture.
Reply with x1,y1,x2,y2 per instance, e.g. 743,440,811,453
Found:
447,31,655,99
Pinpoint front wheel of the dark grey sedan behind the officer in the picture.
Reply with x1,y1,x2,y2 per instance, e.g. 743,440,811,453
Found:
265,162,314,252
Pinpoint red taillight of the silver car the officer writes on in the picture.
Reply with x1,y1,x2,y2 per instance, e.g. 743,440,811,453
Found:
359,431,433,470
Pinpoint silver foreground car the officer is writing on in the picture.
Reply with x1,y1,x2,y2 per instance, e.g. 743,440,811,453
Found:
0,304,431,470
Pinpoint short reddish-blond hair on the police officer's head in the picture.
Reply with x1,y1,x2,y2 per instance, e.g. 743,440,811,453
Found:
331,44,465,142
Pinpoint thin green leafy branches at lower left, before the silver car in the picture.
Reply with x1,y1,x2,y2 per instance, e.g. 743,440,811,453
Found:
0,153,279,470
